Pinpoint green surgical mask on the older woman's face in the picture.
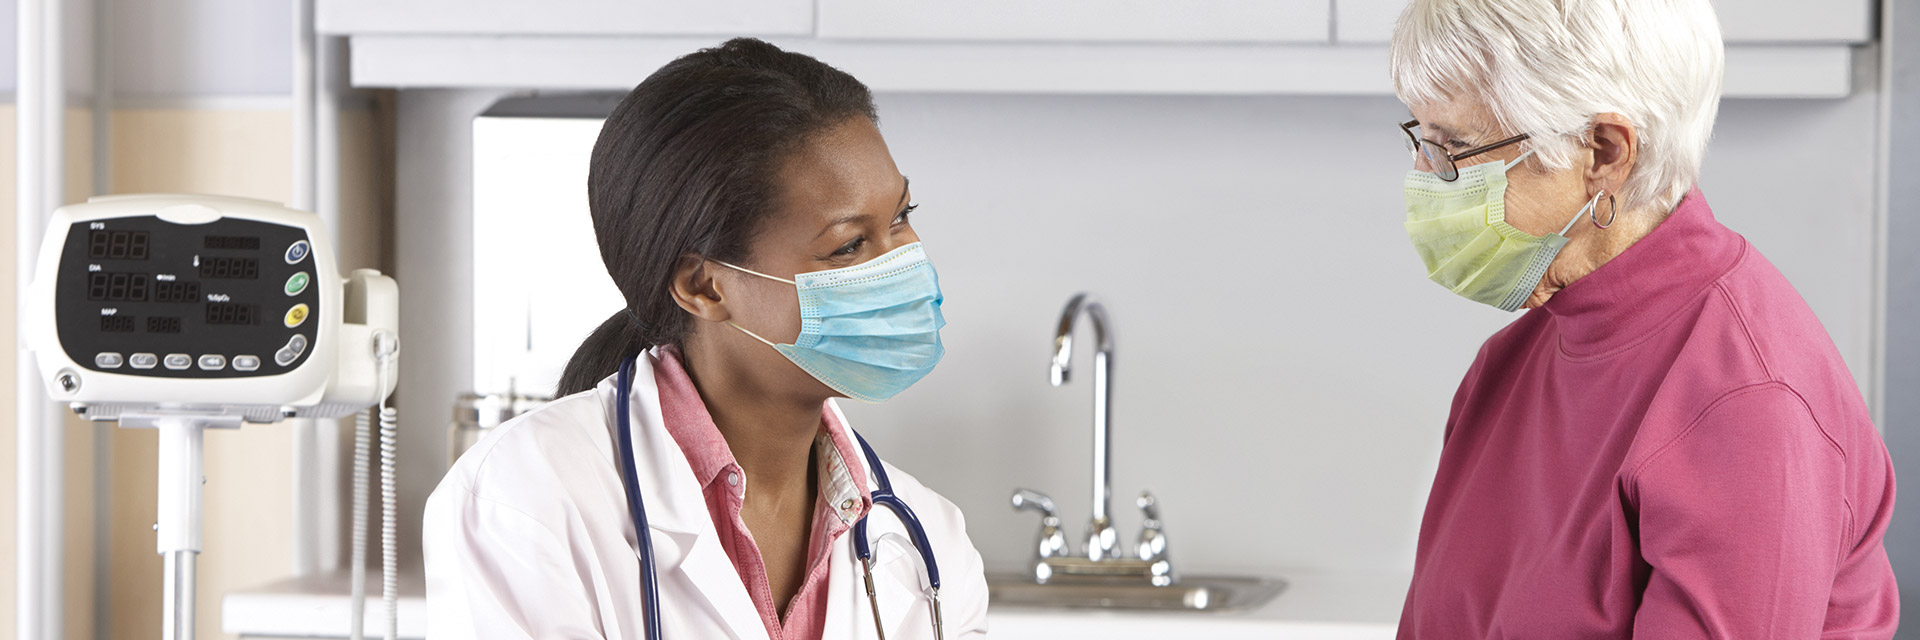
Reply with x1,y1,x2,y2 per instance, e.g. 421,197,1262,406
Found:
1405,152,1599,311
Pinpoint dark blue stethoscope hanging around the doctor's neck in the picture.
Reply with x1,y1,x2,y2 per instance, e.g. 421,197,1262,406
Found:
614,357,947,640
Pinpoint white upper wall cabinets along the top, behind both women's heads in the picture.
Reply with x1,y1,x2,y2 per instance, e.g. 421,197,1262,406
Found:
317,0,1858,98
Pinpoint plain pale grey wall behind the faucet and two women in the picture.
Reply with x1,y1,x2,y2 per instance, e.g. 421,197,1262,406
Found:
476,78,1876,573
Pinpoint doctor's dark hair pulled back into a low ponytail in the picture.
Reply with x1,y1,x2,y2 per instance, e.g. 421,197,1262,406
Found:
555,38,879,396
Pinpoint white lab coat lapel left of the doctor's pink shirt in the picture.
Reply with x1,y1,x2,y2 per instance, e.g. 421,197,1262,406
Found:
607,352,768,640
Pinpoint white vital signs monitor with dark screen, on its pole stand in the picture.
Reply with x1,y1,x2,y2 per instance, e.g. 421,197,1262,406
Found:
21,194,399,640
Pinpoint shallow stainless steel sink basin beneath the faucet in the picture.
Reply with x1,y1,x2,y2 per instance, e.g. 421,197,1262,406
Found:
987,573,1286,611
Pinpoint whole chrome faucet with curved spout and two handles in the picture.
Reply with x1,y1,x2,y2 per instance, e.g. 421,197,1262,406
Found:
1014,294,1175,586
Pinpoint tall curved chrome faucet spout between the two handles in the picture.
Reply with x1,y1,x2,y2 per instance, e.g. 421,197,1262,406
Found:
1050,292,1119,559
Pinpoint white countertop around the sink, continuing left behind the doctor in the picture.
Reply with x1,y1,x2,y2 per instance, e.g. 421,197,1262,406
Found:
221,571,1407,640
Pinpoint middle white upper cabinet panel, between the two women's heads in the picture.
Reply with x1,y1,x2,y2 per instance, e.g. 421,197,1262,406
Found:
816,0,1331,42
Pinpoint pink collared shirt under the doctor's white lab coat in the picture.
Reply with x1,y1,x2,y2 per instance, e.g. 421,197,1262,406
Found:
653,346,874,640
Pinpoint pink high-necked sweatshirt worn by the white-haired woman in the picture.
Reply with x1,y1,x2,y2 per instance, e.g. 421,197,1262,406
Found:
1400,190,1899,640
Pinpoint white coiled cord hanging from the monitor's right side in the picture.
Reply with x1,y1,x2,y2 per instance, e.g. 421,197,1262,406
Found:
349,331,399,640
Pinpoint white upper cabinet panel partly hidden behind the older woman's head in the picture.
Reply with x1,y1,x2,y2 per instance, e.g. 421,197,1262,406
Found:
1332,0,1866,44
